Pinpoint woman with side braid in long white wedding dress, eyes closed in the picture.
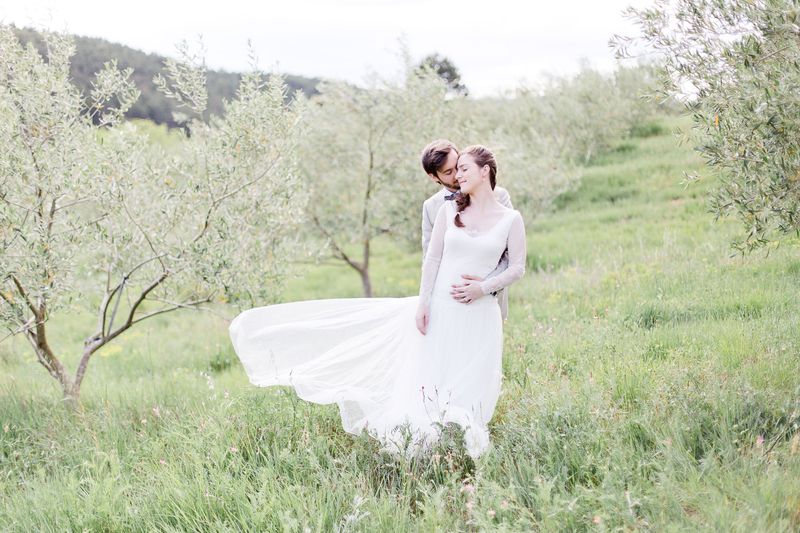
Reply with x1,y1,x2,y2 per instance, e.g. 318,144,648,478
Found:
230,145,526,457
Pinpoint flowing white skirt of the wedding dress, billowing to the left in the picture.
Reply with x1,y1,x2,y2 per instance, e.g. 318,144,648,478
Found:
230,290,502,457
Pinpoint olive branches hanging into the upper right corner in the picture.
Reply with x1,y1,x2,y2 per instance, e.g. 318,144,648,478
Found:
612,0,800,253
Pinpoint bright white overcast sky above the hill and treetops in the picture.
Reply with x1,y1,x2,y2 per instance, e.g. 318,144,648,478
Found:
0,0,651,96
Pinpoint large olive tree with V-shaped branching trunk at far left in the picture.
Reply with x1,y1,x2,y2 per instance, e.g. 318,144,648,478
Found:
0,26,305,404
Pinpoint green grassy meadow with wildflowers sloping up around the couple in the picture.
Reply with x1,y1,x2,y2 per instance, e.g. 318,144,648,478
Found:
0,119,800,532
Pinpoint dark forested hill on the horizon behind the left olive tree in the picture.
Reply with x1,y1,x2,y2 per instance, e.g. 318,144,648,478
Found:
14,28,320,127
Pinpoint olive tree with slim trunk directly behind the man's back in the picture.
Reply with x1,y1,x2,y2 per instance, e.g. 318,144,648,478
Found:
300,63,456,297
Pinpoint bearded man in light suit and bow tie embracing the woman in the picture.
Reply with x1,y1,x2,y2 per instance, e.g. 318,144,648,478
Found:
422,139,513,320
